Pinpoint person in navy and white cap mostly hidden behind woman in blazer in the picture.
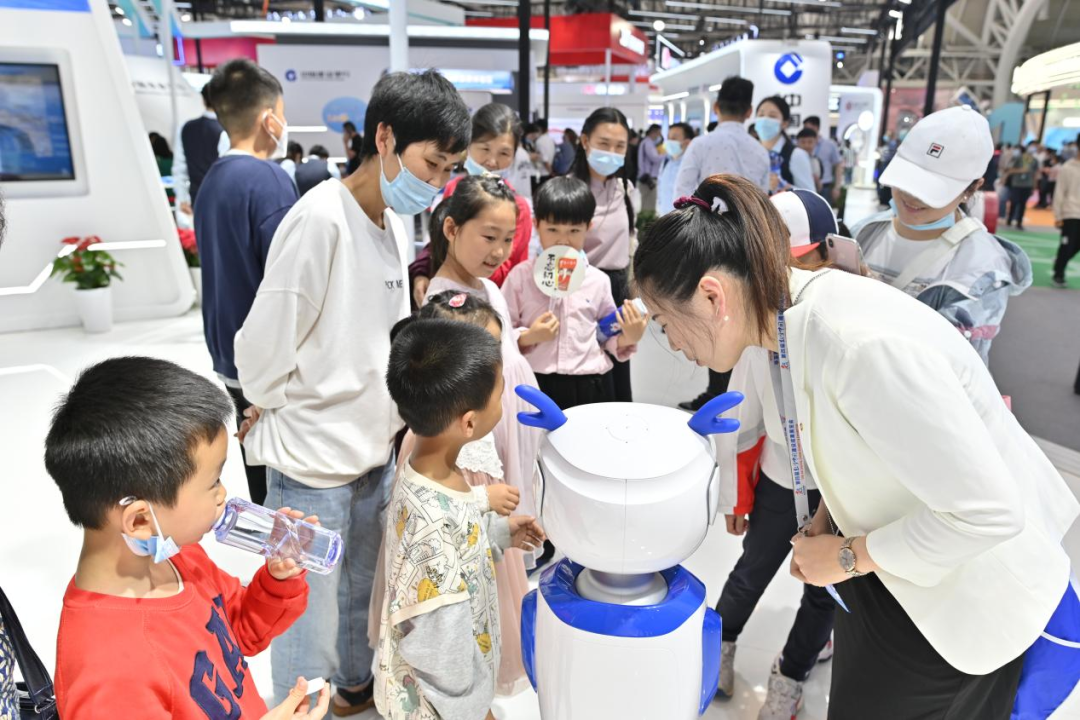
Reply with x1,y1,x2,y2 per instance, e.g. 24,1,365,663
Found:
717,190,837,720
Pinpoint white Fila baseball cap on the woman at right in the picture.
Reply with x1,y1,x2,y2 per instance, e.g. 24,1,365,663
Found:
881,105,994,207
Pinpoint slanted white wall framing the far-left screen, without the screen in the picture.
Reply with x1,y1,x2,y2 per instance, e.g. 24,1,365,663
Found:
0,0,194,331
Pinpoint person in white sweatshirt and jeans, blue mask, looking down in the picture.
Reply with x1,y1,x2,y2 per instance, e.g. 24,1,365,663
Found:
235,71,472,715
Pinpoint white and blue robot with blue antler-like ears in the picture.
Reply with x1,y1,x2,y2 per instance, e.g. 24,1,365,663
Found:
517,385,743,720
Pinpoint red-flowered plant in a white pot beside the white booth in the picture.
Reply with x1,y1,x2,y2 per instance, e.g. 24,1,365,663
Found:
52,235,123,332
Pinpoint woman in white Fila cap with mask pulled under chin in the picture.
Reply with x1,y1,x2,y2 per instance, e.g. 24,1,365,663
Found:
853,106,1031,363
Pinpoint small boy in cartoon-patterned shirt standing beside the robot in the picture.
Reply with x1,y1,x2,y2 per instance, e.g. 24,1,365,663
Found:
375,318,543,720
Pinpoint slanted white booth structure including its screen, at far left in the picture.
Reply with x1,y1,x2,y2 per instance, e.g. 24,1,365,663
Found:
0,0,194,332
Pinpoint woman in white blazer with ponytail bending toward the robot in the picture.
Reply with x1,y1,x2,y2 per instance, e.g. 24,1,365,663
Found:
634,175,1080,720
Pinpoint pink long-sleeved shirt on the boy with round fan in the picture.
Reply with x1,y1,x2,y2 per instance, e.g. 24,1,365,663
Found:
502,258,637,375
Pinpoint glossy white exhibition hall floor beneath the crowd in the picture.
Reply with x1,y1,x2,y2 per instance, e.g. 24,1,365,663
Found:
0,306,1080,720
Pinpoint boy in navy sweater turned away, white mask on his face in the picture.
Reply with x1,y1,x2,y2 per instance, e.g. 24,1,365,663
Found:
195,59,298,504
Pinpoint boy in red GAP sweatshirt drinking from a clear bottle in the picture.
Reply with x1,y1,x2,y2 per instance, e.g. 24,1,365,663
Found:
45,357,329,720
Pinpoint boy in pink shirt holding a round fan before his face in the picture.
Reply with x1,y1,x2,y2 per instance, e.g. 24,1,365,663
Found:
502,176,649,410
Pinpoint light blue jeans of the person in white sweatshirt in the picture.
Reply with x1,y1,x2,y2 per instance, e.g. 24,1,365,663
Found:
267,454,394,703
